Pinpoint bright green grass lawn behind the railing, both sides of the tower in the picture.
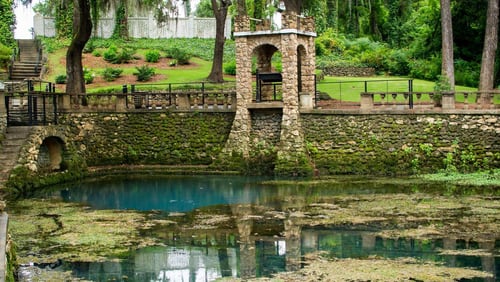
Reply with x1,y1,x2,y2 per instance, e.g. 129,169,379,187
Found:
45,44,492,104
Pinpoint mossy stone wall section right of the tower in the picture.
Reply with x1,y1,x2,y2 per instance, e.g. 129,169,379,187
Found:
302,114,500,175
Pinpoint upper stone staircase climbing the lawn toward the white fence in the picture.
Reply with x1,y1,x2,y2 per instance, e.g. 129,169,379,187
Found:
10,39,42,81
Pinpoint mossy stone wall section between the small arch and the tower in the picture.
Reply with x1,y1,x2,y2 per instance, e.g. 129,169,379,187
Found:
59,113,234,166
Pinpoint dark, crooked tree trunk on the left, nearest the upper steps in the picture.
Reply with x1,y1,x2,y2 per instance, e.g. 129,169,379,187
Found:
66,0,92,102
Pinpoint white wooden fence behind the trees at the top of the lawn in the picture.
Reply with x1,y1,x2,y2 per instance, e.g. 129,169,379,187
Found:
33,14,231,38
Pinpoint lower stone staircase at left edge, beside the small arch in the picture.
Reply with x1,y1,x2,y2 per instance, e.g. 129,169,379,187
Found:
0,126,31,188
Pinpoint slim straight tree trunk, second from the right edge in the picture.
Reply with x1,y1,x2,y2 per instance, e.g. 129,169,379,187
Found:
441,0,455,90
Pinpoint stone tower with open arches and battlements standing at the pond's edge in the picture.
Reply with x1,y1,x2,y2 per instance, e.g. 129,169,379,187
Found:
225,12,316,175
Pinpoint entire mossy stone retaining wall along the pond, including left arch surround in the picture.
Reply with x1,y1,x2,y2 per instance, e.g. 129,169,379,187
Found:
7,111,500,180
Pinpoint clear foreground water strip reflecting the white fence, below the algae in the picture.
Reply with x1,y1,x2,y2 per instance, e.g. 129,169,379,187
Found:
57,230,500,281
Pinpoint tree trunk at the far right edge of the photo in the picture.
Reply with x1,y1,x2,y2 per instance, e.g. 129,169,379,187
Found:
479,0,499,90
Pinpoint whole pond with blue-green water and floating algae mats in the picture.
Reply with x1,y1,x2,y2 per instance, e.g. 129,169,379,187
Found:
10,176,500,281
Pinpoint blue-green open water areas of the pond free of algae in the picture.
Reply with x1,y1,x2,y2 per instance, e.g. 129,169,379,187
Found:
16,176,500,281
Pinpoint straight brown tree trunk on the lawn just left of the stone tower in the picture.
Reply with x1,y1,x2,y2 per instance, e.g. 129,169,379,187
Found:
207,0,231,82
